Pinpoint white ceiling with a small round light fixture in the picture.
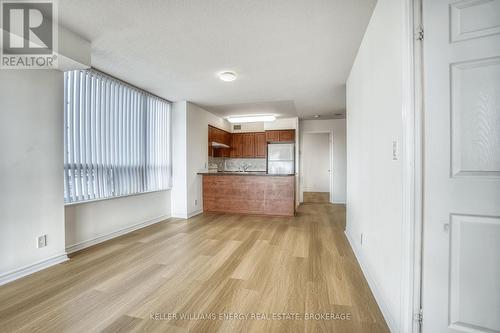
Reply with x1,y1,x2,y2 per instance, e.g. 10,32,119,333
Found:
59,0,376,118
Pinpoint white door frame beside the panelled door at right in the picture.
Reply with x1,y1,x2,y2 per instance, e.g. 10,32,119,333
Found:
400,0,424,333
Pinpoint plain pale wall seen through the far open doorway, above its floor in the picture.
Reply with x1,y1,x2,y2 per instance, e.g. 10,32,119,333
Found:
302,133,331,192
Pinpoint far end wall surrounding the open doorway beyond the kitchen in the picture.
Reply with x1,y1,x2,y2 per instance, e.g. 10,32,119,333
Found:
300,119,347,203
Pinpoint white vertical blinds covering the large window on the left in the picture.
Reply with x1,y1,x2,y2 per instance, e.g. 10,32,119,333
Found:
64,70,172,203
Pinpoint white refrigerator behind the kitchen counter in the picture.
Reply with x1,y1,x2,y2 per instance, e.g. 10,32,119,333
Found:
267,142,295,175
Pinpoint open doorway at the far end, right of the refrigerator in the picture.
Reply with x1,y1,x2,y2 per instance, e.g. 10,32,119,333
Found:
301,132,333,202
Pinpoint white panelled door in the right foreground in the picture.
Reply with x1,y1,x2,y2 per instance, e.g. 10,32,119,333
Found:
422,0,500,333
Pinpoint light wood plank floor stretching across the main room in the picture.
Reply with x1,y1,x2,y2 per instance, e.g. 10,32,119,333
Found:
0,203,389,333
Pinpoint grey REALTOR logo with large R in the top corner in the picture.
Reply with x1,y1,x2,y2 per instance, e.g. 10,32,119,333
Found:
0,0,57,69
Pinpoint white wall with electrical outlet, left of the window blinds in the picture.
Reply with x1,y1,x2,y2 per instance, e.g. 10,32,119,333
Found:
0,70,65,282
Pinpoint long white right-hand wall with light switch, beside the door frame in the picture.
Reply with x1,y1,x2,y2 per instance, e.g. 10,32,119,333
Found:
346,0,403,332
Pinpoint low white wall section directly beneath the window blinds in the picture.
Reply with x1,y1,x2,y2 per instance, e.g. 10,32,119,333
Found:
65,191,171,252
